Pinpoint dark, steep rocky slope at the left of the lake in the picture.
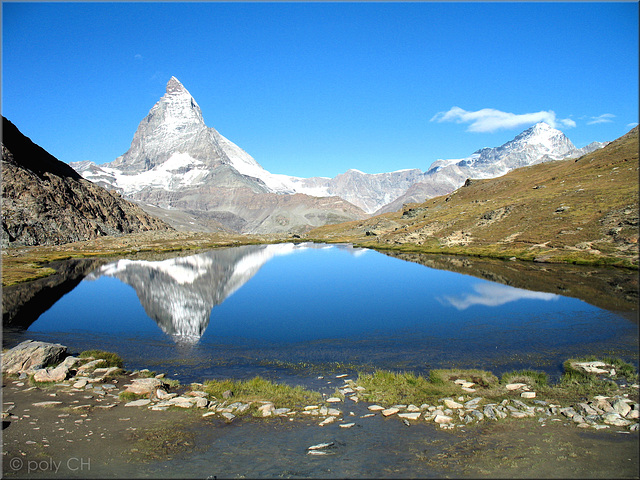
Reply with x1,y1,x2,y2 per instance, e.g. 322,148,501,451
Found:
2,117,171,247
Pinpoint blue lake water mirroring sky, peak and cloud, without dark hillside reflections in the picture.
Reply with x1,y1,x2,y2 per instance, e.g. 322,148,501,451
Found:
5,243,638,383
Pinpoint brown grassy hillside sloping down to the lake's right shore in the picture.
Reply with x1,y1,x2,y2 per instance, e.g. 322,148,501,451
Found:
306,127,639,268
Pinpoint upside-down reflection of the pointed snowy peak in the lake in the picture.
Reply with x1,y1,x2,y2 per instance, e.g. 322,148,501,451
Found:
87,243,309,343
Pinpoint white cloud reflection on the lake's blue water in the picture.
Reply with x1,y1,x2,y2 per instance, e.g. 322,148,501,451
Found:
438,283,559,310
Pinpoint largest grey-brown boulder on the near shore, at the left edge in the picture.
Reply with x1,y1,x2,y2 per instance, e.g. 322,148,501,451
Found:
2,340,67,374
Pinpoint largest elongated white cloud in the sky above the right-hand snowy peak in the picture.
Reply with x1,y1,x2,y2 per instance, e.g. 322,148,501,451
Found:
431,107,576,133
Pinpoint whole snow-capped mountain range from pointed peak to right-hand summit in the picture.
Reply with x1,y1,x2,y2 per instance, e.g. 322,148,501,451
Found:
71,77,606,233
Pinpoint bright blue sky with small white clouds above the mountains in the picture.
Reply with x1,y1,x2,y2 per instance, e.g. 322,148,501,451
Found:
2,2,639,177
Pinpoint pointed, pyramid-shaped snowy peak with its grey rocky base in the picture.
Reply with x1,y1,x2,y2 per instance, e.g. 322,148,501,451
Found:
72,77,365,233
